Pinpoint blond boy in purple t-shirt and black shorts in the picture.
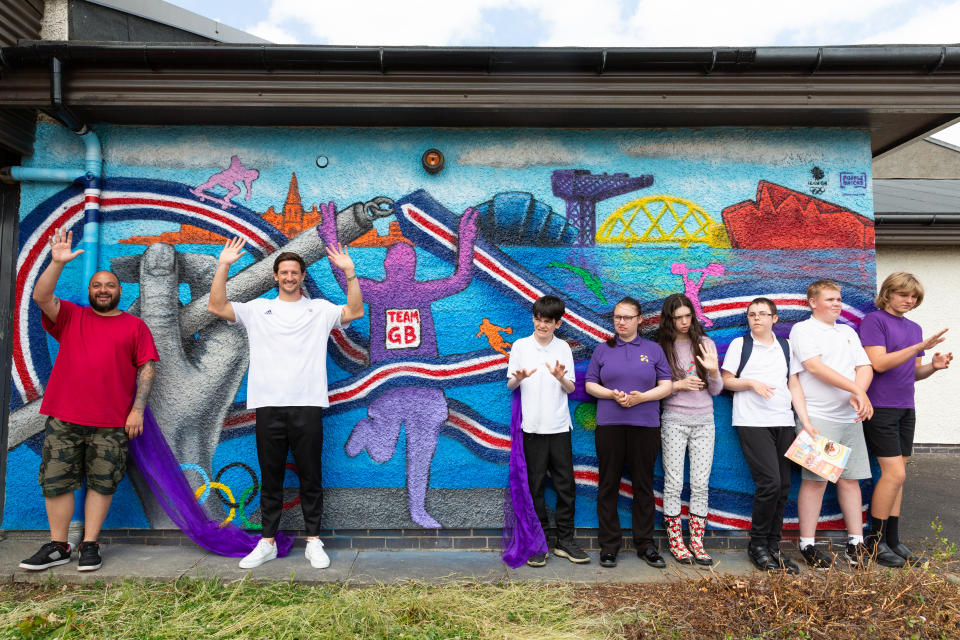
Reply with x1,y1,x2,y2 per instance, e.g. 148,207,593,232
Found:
860,272,953,567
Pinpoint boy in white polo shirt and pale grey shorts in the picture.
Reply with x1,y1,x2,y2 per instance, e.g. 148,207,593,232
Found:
790,280,873,569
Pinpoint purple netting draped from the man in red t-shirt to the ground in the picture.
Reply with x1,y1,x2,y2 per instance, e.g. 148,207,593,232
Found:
130,407,293,558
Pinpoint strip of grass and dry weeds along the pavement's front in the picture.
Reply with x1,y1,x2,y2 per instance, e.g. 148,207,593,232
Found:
0,563,960,640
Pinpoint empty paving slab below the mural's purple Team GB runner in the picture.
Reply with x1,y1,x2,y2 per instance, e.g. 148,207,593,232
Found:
350,551,507,584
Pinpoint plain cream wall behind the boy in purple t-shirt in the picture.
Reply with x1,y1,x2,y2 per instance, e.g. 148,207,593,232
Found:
877,246,960,444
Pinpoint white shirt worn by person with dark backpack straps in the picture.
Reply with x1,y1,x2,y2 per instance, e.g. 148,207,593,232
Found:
722,337,794,427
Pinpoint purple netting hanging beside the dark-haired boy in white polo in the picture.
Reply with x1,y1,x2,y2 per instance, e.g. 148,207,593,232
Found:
500,389,547,569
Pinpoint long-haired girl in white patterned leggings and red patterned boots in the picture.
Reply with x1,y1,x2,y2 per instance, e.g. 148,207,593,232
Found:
657,293,723,566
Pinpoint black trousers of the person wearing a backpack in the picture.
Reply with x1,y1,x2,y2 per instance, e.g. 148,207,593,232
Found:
737,427,796,549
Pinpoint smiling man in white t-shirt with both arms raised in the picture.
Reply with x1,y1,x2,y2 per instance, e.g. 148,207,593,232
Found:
207,238,363,569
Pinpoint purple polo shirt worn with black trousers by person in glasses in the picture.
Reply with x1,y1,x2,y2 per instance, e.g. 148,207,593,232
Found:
586,336,673,427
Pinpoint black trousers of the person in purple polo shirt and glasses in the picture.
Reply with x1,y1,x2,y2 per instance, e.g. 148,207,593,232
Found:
595,425,660,553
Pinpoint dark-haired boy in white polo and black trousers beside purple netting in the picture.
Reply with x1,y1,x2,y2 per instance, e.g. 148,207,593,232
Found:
507,296,590,567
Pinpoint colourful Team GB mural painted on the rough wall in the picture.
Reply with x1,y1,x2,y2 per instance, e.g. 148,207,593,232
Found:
3,125,875,529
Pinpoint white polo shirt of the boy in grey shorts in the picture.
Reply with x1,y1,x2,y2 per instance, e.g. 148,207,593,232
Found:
790,316,870,422
